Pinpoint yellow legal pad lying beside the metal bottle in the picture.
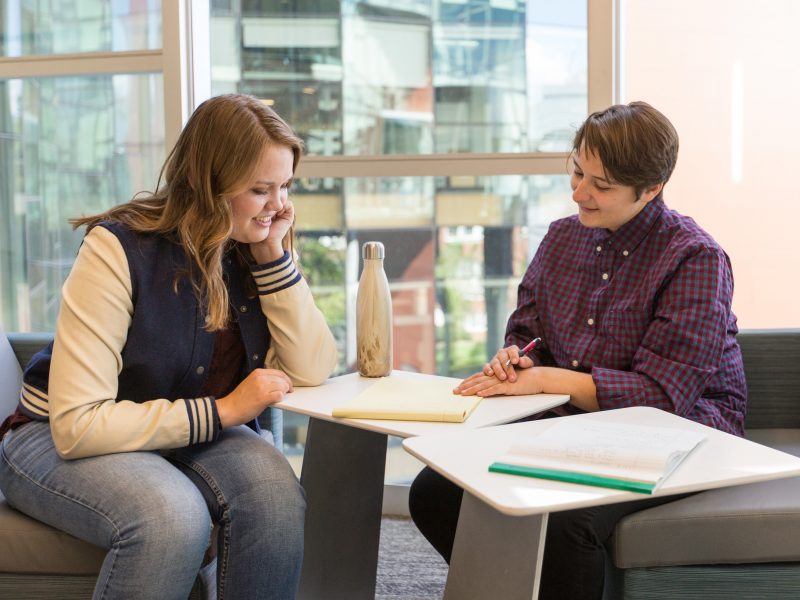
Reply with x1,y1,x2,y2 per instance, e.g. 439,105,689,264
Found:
332,376,481,423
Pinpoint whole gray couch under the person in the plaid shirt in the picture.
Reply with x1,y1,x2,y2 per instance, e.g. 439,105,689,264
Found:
606,329,800,600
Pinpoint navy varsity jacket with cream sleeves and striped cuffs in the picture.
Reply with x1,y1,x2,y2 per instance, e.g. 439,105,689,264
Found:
20,222,336,458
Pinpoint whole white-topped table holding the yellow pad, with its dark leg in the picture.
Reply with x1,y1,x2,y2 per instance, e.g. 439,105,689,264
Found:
274,371,569,600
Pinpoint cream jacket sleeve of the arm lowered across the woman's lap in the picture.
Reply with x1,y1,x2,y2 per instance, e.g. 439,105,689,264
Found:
48,227,219,459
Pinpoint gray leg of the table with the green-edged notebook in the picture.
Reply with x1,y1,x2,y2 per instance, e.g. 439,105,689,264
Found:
444,492,547,600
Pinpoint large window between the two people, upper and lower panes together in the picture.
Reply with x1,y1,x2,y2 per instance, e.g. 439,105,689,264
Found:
211,0,588,481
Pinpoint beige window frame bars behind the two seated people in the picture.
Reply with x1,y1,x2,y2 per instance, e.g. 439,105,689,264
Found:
0,0,621,506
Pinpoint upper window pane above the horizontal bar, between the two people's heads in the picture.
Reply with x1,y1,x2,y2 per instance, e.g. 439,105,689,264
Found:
211,0,587,156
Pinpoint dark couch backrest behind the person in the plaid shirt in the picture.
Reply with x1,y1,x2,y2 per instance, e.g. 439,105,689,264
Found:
737,329,800,430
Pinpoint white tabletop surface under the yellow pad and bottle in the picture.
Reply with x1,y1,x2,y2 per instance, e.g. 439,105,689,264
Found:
272,371,569,438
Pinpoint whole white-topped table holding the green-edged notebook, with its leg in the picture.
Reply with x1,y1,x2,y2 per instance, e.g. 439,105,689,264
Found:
403,407,800,600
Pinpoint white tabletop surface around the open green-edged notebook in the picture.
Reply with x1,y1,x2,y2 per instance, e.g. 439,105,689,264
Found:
403,406,800,516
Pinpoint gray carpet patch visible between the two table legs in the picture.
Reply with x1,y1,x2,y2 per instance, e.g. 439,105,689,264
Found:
375,517,447,600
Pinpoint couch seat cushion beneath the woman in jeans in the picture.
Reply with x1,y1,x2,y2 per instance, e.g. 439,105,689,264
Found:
0,494,106,575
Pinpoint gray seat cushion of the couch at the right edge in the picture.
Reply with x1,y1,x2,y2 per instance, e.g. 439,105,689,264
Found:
611,477,800,568
